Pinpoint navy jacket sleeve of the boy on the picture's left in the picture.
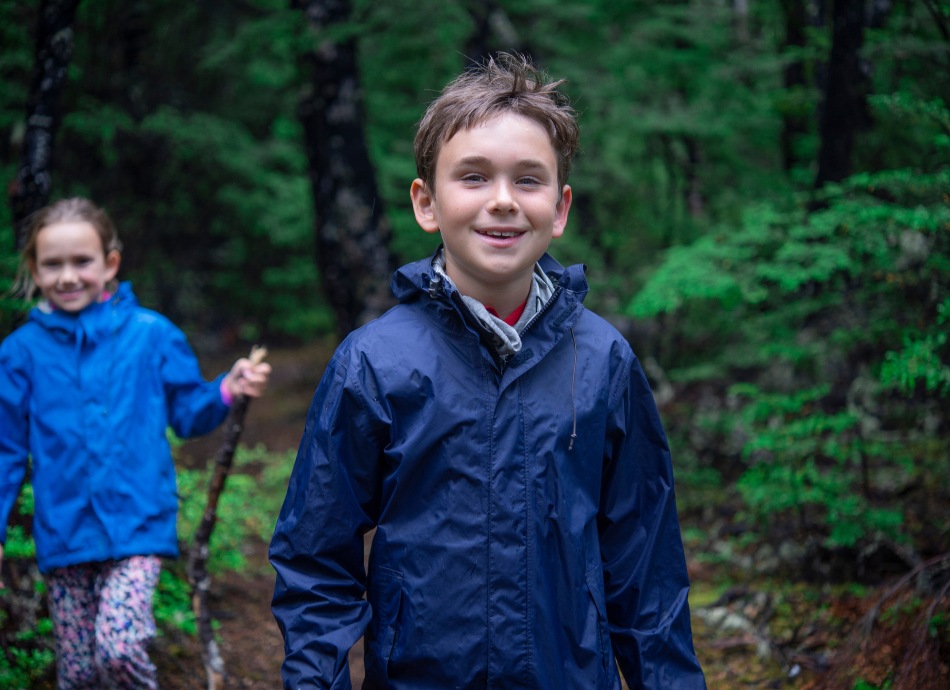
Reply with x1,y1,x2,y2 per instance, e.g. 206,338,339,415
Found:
270,358,381,690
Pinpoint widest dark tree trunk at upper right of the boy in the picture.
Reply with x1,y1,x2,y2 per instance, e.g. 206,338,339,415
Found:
815,0,869,189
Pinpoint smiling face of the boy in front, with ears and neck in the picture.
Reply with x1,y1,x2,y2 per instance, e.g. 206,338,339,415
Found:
411,113,571,316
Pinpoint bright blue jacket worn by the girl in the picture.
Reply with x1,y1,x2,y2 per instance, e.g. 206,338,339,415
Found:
0,283,228,572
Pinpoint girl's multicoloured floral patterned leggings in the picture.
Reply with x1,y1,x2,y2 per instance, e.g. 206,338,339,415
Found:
46,556,162,690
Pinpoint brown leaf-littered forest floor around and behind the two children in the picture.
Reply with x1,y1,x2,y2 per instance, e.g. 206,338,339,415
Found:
153,348,950,690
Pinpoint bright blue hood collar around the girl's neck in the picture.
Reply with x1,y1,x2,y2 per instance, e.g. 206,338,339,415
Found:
29,282,139,343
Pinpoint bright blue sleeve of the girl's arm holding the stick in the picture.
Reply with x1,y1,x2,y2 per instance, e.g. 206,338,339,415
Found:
161,322,230,438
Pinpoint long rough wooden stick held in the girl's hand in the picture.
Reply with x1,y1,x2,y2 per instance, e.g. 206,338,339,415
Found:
188,346,267,690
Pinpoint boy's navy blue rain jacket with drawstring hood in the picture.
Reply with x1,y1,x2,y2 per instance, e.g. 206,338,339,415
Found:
270,256,705,690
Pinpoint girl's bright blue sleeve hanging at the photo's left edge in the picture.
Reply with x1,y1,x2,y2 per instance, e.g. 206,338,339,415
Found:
0,339,30,544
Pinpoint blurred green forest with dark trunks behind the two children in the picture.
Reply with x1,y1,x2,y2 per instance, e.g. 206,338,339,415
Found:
0,0,950,690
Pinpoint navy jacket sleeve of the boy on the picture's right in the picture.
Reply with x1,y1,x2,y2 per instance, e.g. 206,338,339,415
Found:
600,354,706,690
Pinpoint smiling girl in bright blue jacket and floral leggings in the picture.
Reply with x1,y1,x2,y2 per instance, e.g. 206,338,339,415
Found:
0,199,270,689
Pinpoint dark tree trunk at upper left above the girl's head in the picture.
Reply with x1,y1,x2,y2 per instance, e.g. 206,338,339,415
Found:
9,0,79,250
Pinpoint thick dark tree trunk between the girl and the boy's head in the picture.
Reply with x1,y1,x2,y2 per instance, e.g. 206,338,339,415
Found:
292,0,396,338
